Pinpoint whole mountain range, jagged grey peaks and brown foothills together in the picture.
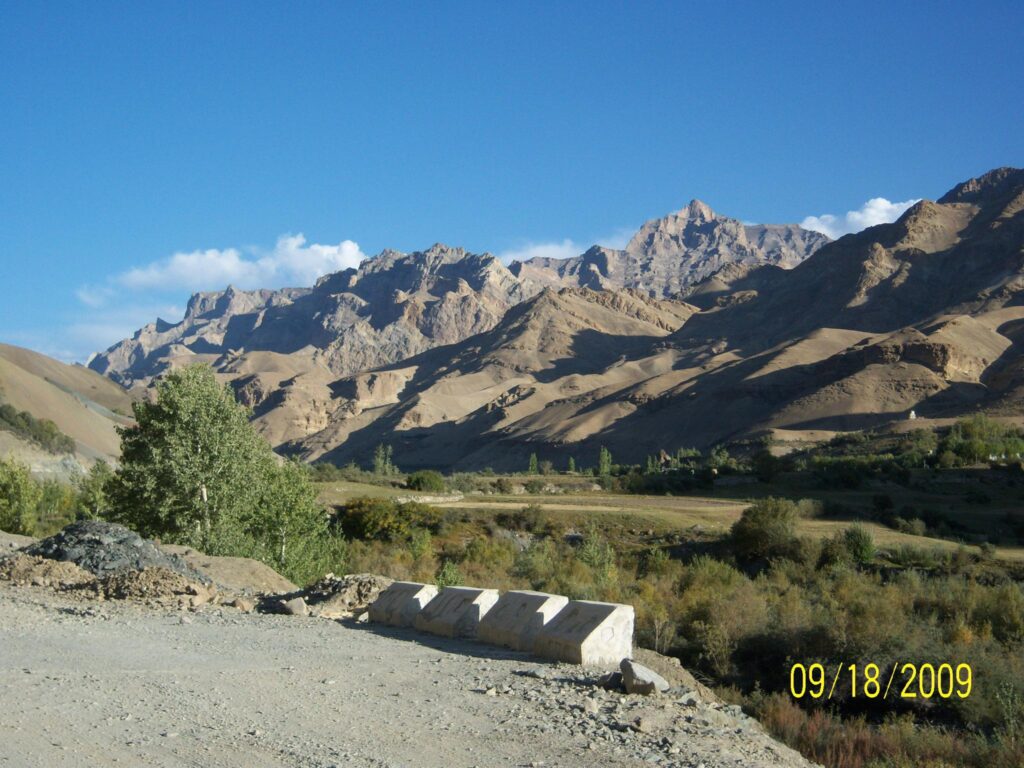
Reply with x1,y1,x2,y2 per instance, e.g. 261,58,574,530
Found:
4,168,1024,469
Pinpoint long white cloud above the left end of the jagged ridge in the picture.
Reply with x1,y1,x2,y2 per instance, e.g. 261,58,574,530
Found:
115,234,366,292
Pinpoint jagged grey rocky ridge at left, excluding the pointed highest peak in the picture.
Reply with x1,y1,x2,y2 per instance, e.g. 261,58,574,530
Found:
89,245,538,385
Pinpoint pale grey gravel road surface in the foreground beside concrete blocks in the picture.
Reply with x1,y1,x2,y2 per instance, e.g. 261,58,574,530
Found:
0,584,806,768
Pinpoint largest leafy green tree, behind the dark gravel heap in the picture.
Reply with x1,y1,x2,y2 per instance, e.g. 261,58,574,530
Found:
109,366,274,553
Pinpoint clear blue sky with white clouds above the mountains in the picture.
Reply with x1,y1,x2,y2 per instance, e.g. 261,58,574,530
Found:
0,0,1024,359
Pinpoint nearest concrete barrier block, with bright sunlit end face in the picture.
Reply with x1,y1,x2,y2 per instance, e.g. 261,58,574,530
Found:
534,600,634,667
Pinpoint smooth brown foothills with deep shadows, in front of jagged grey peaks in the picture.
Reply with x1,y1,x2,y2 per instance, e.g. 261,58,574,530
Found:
282,171,1024,469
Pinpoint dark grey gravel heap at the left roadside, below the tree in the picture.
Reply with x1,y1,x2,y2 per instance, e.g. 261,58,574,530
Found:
23,520,210,584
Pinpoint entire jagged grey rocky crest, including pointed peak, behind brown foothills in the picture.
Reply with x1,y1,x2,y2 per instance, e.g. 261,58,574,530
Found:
89,201,827,397
